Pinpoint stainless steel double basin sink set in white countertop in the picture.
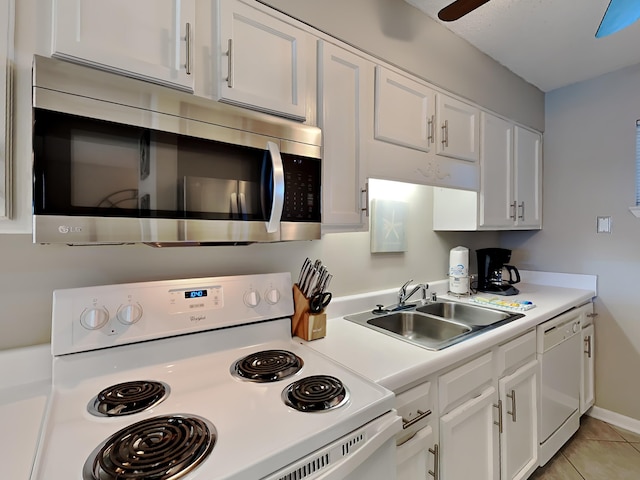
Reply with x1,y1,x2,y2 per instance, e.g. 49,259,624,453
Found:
345,301,524,350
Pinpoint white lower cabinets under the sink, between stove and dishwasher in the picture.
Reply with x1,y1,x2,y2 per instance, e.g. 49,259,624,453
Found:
404,330,539,480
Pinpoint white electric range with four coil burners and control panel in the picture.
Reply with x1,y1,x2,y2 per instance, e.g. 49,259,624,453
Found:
32,273,401,480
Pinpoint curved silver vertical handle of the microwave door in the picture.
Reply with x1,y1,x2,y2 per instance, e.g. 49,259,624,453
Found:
262,142,284,233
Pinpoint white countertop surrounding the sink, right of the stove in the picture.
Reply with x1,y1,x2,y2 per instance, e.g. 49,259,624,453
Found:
298,272,596,393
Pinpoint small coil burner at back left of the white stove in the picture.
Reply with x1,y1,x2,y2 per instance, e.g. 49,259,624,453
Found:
87,380,170,417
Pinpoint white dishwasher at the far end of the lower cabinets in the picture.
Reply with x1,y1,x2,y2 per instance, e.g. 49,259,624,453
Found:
537,308,582,466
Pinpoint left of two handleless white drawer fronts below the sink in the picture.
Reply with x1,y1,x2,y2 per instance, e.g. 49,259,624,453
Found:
438,352,493,415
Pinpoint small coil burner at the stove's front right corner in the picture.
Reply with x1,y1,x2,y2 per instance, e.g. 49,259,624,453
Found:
282,375,349,412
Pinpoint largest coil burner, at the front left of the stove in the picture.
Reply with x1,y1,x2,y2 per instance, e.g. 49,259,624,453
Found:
82,415,217,480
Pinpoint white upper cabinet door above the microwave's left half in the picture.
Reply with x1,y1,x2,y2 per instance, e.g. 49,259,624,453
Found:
52,0,195,91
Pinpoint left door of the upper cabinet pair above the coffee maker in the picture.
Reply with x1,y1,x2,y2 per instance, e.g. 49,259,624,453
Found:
479,112,516,228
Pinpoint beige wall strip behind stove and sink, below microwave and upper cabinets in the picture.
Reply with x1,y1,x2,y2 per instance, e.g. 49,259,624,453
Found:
0,185,498,350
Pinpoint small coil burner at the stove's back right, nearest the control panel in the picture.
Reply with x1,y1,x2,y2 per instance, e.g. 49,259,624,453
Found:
231,350,304,383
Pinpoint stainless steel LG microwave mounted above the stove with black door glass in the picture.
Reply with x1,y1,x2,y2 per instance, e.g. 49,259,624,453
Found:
33,56,321,246
